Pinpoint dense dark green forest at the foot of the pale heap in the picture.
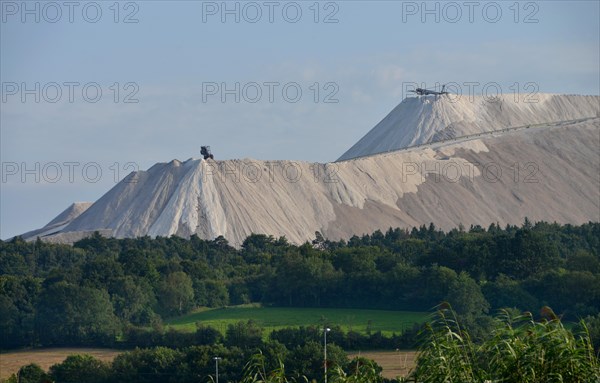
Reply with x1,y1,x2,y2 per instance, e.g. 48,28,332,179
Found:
0,220,600,349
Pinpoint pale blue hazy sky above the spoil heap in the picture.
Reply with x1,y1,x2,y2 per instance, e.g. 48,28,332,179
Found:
0,0,600,239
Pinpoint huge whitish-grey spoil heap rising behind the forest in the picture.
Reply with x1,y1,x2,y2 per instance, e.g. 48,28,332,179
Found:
24,95,600,246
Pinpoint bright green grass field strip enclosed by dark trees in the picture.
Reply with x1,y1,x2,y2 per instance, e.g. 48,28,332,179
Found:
165,306,428,335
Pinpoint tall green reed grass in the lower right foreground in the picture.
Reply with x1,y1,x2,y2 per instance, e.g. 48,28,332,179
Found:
406,304,600,383
